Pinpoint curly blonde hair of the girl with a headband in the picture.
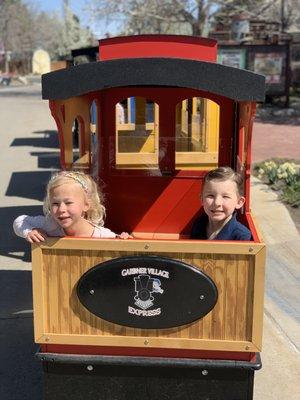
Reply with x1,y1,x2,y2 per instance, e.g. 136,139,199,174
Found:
43,171,105,226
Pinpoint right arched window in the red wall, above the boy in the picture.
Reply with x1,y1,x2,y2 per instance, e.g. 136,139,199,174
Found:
175,97,219,170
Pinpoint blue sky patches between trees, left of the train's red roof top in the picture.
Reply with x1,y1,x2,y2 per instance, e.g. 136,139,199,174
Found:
29,0,115,39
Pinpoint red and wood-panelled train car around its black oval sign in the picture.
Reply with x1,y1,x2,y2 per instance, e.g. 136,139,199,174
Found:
32,35,265,361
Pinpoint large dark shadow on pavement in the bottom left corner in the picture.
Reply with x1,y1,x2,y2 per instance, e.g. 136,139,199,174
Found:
0,270,42,400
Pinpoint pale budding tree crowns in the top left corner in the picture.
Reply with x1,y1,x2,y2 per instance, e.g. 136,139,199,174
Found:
0,0,94,60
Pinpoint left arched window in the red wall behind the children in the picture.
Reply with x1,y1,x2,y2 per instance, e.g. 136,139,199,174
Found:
115,97,159,169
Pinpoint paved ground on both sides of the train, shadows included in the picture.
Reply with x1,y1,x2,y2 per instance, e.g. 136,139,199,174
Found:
0,85,300,400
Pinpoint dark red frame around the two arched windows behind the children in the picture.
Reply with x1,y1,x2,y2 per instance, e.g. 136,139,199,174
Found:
102,87,227,176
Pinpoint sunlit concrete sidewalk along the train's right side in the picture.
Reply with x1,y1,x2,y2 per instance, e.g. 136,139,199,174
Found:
251,178,300,400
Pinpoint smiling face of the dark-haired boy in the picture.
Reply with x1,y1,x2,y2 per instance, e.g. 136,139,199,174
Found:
202,180,245,223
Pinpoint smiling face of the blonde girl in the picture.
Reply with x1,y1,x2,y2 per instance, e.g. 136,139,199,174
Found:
50,183,89,231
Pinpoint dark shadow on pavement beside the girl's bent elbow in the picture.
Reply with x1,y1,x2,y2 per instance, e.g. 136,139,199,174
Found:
0,206,43,262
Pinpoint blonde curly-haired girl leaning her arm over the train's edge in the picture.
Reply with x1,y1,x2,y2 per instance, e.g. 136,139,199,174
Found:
13,171,130,243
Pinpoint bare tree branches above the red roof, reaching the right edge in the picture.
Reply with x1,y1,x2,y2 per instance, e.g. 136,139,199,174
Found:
87,0,300,36
